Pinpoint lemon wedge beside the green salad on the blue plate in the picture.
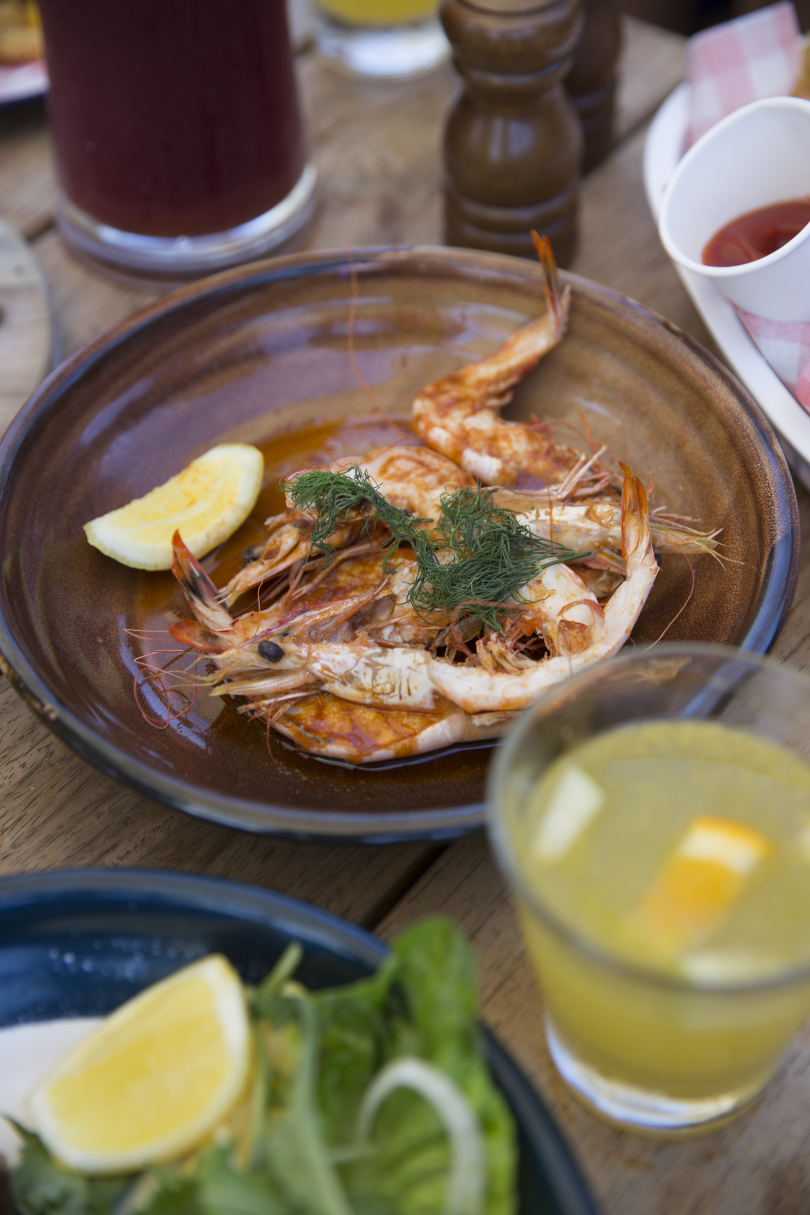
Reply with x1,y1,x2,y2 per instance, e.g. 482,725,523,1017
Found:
28,954,250,1174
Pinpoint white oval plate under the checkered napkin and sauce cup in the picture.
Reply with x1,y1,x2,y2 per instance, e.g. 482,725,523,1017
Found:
644,84,810,488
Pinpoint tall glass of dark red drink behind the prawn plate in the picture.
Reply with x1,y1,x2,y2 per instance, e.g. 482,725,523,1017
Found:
40,0,316,279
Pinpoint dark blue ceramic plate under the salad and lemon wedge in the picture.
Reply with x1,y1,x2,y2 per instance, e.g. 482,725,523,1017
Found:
0,869,596,1215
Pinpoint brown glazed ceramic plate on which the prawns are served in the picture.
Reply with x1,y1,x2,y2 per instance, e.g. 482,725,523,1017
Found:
0,249,799,840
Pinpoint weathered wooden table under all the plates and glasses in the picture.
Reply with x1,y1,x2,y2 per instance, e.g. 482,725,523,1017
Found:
0,19,810,1215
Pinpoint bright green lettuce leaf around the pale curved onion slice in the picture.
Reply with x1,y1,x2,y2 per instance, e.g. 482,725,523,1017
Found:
313,919,516,1215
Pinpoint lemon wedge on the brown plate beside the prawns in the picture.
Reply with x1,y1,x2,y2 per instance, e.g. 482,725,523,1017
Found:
84,443,265,570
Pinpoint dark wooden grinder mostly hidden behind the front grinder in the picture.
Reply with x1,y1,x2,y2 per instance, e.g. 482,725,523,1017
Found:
566,0,622,173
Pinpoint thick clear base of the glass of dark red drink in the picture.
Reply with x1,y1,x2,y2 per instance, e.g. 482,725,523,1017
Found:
56,164,316,281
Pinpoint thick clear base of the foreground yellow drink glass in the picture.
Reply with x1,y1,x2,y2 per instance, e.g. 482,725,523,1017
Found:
545,1015,763,1134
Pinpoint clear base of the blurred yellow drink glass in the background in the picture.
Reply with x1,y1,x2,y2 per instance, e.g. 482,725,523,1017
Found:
316,15,451,80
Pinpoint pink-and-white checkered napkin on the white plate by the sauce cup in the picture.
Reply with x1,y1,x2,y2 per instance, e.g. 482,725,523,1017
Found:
687,0,810,412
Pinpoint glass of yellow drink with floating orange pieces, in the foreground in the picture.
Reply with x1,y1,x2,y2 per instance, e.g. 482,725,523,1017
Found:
491,644,810,1131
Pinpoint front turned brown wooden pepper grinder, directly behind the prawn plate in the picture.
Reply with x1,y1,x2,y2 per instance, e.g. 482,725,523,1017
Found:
440,0,583,266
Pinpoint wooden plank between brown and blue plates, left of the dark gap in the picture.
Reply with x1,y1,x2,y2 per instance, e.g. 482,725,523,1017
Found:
0,679,437,926
